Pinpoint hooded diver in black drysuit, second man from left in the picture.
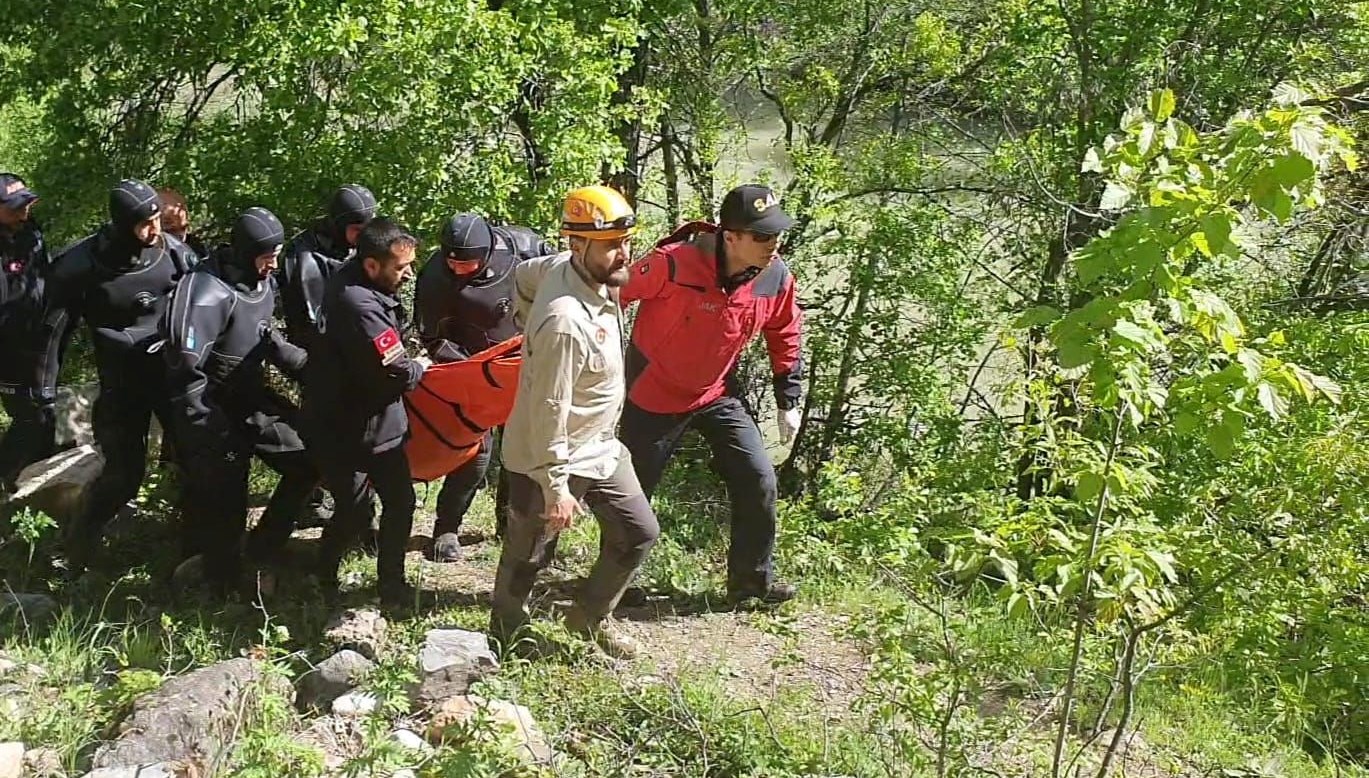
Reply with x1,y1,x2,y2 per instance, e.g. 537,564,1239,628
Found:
40,179,196,568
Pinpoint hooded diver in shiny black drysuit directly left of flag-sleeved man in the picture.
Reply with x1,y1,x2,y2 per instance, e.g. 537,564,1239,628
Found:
162,208,319,593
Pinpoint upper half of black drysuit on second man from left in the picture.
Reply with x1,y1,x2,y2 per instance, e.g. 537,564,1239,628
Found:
40,226,196,390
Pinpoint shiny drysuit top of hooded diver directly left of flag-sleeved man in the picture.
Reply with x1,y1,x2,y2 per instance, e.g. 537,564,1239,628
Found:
160,247,307,451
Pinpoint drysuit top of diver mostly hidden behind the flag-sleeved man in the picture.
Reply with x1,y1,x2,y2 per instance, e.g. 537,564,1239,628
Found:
278,226,355,348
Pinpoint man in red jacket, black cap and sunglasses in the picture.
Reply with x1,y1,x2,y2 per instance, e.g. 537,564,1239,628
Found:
622,185,804,604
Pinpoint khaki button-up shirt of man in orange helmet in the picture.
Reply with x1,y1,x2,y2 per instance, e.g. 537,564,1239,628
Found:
502,252,627,503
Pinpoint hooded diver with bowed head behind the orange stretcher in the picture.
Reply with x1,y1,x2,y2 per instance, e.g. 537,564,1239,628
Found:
413,214,556,562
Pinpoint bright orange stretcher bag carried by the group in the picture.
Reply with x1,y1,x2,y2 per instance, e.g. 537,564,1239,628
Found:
404,336,523,481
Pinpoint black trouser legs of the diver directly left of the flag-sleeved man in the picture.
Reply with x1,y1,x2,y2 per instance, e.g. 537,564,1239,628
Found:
177,426,319,586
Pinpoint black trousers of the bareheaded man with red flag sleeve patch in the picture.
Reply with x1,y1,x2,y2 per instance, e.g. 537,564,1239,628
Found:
311,441,416,596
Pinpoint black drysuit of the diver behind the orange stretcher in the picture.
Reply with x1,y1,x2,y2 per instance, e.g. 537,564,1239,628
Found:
413,226,556,538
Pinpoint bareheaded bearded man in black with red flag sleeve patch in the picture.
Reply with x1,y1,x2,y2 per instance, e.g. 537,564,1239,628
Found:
304,218,430,607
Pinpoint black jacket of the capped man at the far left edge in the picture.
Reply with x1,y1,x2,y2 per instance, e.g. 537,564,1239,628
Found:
0,221,51,392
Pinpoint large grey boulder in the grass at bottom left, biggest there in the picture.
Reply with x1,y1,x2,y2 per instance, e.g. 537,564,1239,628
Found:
92,657,293,767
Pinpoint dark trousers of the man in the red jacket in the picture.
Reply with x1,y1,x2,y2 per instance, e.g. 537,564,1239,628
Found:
622,397,778,592
